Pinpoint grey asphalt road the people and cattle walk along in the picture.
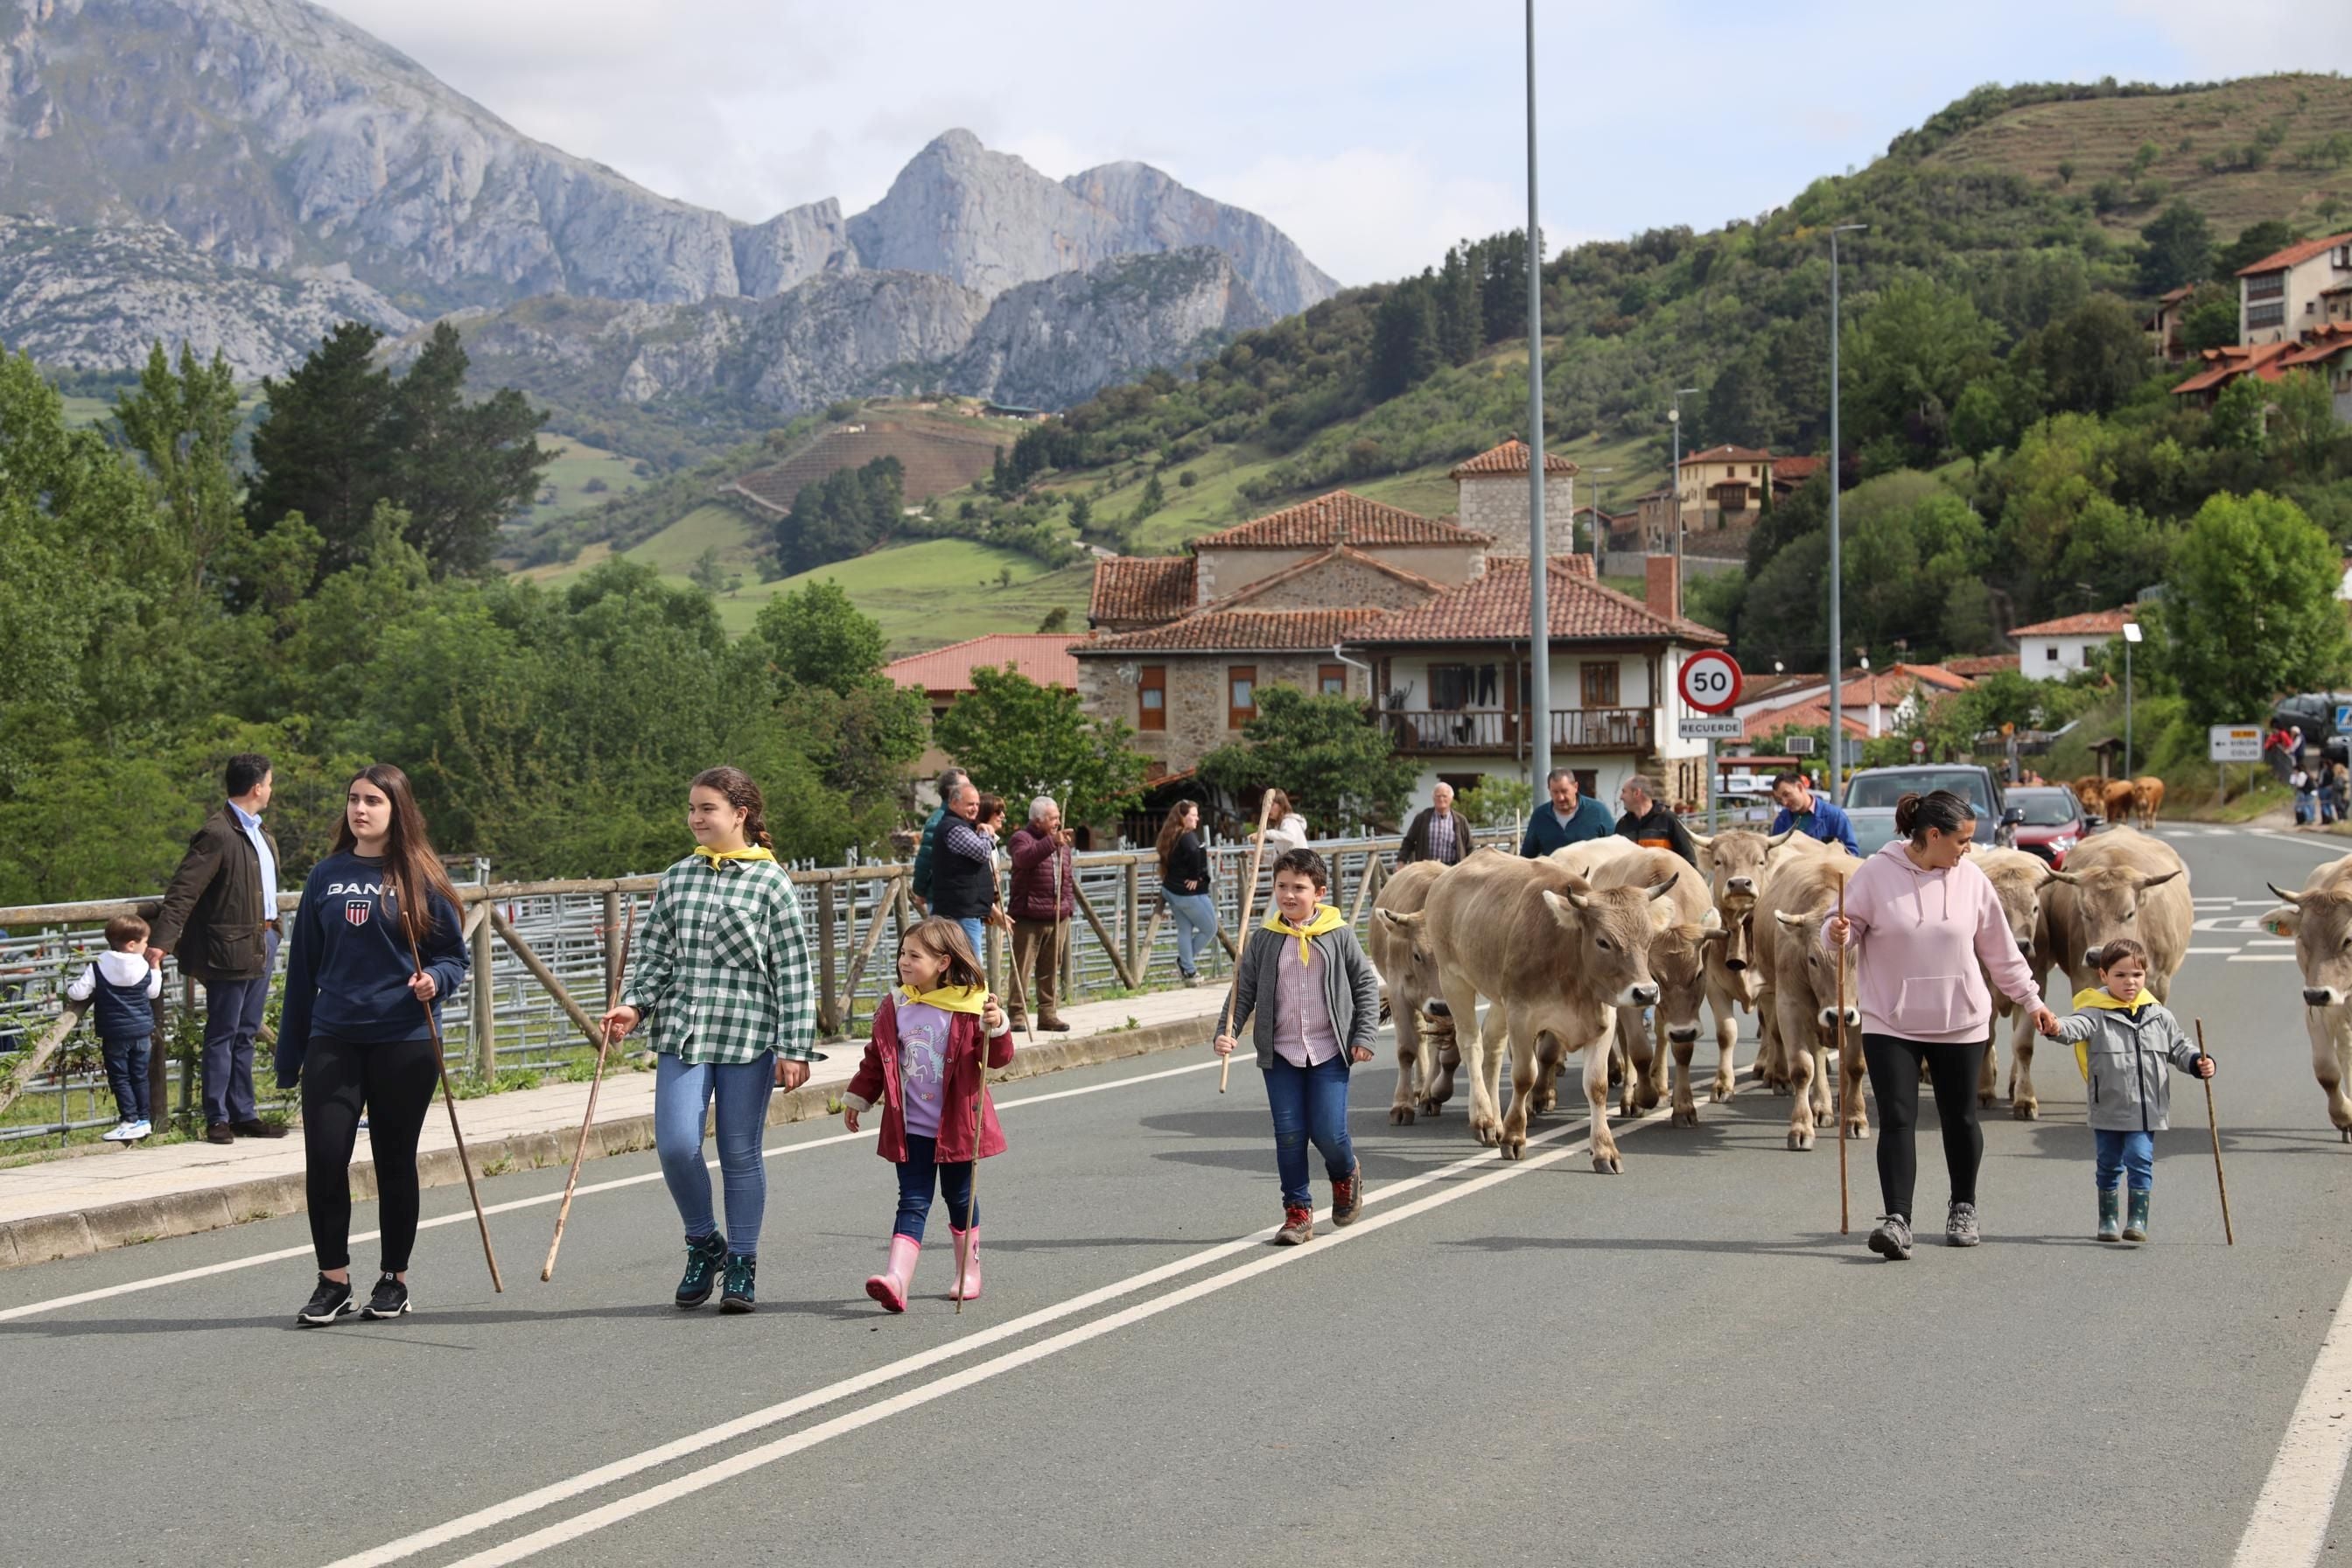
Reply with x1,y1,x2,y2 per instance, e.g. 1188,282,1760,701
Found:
13,830,2352,1568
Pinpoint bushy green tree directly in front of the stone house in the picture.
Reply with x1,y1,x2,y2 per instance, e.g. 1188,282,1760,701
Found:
1200,687,1421,830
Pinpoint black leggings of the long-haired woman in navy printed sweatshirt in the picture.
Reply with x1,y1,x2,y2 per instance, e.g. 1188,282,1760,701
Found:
301,1040,440,1274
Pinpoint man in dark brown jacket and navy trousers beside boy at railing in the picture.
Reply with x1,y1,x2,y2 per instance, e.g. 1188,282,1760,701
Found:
148,752,287,1143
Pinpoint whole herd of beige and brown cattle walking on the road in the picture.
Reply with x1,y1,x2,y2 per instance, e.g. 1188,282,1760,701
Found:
1368,822,2201,1173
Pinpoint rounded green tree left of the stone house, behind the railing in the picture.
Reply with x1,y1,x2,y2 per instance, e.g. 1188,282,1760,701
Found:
934,665,1143,822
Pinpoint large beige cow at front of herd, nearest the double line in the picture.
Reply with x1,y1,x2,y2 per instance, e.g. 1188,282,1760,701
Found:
1381,856,1672,1173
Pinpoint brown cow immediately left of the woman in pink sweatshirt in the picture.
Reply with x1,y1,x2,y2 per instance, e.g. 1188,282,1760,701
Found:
1757,849,1870,1150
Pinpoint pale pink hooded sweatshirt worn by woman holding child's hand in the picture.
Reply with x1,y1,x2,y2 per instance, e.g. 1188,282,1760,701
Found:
1823,839,2041,1044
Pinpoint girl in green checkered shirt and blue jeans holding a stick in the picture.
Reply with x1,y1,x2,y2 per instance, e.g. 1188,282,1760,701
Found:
605,769,816,1312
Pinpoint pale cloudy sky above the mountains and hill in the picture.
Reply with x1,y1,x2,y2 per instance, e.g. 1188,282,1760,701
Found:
325,0,2352,282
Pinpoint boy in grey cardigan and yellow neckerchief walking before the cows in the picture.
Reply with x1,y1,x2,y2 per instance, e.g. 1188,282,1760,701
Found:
1216,849,1381,1246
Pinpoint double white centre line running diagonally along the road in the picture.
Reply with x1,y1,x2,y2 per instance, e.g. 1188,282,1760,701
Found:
329,1069,1721,1568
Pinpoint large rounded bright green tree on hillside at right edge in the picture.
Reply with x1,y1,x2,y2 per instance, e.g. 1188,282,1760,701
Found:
2154,492,2352,724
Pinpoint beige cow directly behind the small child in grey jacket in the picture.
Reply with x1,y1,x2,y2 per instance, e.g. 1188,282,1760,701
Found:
2009,827,2197,1122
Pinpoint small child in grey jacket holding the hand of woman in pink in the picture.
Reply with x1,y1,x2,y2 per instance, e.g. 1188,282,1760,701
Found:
2054,935,2213,1242
